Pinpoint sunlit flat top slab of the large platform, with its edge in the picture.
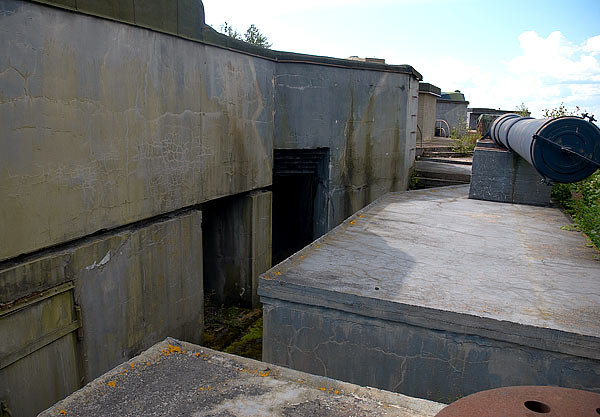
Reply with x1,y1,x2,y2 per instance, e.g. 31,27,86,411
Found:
259,186,600,359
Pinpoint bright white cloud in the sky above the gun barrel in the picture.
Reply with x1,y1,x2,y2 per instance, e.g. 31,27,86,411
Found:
408,31,600,118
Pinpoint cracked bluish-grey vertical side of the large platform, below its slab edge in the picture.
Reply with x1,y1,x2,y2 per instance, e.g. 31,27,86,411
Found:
263,298,600,403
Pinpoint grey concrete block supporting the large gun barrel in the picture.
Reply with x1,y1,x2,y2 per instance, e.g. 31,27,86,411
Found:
469,141,552,206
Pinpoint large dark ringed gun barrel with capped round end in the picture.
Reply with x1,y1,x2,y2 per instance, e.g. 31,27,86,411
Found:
488,113,600,183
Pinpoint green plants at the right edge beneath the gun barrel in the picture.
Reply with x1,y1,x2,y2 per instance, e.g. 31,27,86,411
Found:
552,170,600,252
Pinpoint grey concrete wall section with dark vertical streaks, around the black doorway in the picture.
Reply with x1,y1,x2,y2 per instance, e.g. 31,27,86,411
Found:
274,63,418,228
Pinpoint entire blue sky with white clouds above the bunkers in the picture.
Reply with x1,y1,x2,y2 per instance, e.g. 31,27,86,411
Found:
203,0,600,119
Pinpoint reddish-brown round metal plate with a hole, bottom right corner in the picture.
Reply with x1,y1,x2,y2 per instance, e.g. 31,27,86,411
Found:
436,386,600,417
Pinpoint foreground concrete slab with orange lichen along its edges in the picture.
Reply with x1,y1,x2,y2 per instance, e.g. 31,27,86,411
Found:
40,339,444,417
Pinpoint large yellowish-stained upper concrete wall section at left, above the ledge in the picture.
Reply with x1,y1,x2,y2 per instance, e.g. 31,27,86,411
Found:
0,0,275,260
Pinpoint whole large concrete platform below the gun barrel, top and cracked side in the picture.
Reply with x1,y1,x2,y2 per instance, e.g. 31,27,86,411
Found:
259,186,600,402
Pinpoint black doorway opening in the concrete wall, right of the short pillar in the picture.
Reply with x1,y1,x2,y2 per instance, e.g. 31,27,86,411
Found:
272,148,329,265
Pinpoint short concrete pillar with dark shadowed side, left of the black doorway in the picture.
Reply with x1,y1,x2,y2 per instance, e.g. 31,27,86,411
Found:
203,191,272,307
